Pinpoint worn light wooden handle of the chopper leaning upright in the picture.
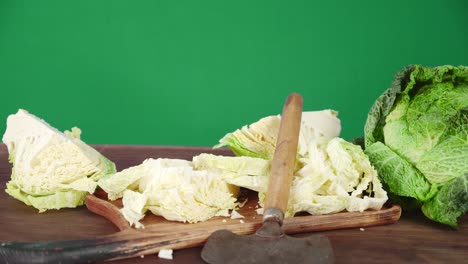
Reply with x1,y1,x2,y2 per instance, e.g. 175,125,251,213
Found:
264,93,302,217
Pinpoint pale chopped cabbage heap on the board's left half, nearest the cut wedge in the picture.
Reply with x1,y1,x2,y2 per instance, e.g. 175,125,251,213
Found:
98,158,239,228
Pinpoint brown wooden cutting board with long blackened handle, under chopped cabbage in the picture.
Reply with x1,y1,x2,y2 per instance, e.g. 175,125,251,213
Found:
0,176,401,264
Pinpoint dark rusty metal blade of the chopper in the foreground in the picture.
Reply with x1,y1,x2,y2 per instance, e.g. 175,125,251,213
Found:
201,230,334,264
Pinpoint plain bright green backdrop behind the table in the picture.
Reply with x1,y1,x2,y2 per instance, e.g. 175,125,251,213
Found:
0,0,468,146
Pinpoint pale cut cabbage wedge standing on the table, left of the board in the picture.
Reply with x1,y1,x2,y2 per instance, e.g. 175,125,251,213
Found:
2,109,116,212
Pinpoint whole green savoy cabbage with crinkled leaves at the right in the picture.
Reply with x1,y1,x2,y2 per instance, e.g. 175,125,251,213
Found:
364,65,468,228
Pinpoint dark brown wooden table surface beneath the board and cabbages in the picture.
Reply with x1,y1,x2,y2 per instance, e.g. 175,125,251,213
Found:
0,144,468,264
